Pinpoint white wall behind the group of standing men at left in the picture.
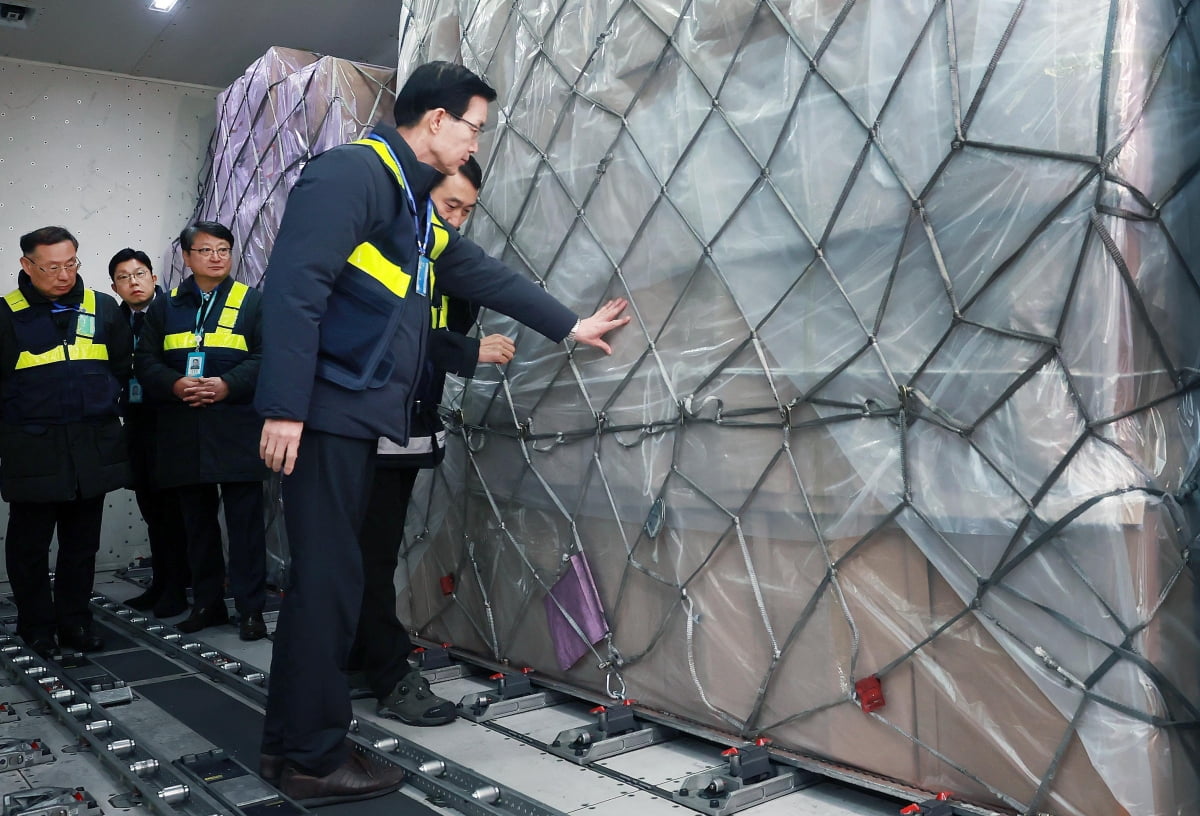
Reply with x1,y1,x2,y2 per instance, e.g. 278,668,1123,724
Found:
0,58,218,568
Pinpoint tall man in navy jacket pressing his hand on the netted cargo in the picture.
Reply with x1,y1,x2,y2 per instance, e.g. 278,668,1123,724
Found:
254,62,629,805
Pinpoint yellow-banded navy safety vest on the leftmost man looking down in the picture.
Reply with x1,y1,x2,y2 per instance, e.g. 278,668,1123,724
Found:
0,288,121,425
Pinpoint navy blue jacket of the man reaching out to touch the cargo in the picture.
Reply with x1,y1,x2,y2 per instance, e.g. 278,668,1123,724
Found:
254,126,576,444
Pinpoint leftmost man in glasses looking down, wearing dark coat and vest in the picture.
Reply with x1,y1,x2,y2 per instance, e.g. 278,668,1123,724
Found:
0,227,132,655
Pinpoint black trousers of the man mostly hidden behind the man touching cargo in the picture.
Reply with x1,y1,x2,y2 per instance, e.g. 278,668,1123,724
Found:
349,467,420,698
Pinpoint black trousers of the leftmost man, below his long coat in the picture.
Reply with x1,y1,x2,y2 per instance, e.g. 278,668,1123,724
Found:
5,496,104,642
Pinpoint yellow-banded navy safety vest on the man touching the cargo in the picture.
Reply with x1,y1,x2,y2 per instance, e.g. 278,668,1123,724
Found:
317,139,450,390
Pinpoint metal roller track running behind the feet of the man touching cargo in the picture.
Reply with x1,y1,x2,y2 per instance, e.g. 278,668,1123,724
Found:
91,595,566,816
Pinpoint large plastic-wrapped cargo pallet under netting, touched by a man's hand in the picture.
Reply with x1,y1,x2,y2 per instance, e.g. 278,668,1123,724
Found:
400,0,1200,816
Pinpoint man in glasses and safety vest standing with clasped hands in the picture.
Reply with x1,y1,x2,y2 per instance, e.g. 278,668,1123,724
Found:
134,221,268,641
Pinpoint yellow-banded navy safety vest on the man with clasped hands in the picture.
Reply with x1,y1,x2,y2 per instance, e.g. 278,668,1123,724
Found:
162,273,258,377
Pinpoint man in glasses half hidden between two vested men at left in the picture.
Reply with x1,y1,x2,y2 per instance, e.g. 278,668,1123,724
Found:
108,247,188,618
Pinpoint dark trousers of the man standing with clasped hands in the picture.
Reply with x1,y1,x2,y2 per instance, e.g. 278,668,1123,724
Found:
175,481,266,614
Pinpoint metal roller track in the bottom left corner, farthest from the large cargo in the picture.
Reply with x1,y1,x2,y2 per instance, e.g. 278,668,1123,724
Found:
0,636,231,816
